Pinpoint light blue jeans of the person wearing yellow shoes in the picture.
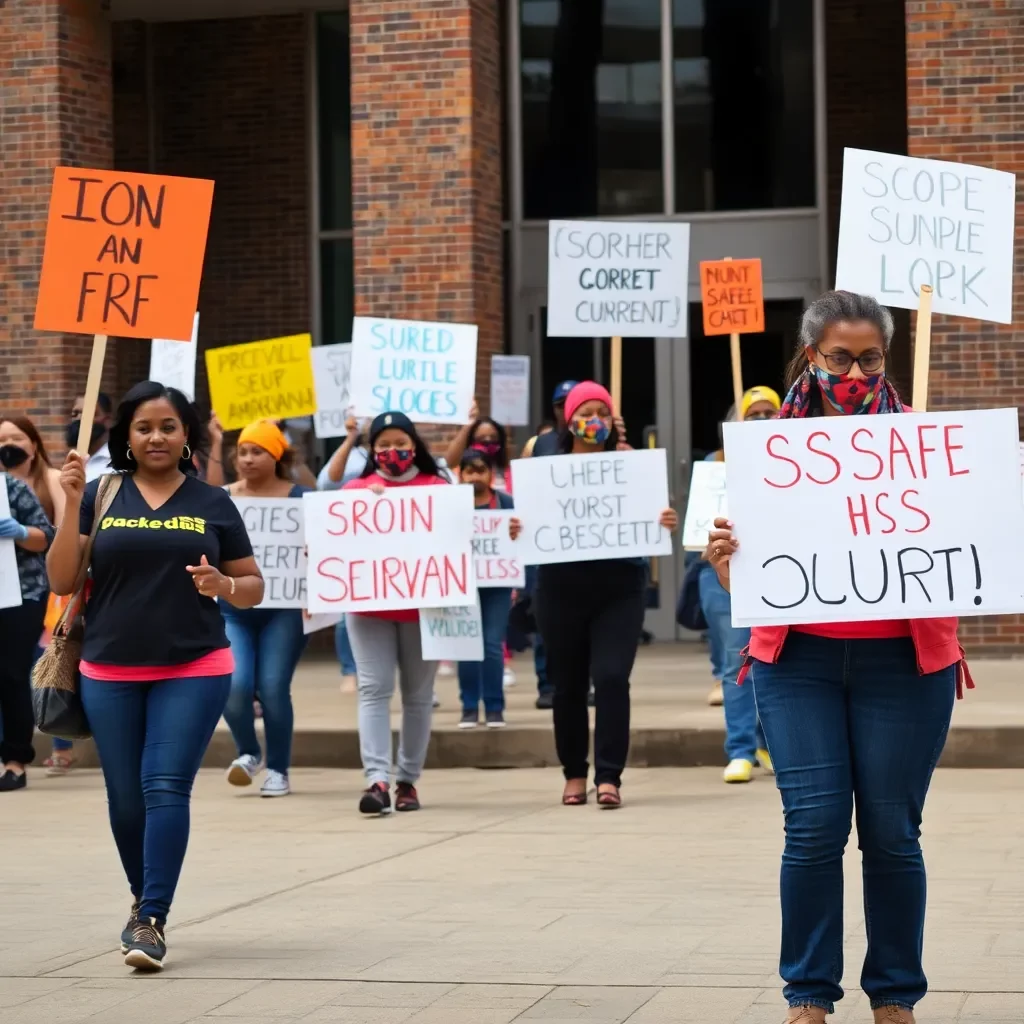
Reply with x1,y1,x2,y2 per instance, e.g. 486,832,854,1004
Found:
698,563,766,763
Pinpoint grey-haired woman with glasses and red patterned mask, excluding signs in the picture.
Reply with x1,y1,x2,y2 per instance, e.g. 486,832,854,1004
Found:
707,292,973,1024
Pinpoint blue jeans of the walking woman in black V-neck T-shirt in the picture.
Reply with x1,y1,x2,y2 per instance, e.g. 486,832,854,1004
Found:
82,676,231,922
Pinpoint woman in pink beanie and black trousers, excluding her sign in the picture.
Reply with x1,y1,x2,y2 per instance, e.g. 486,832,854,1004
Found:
512,381,679,808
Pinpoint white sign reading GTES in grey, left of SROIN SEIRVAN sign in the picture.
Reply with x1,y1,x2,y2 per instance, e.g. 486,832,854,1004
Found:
234,498,306,608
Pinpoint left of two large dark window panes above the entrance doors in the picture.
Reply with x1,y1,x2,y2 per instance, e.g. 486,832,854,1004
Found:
520,0,665,218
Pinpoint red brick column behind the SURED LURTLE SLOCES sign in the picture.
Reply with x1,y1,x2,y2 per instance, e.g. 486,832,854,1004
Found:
349,0,504,423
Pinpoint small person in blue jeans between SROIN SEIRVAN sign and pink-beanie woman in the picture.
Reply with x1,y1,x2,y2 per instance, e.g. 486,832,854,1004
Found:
459,449,513,729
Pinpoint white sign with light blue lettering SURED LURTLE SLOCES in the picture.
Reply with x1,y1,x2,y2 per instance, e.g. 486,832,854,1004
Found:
349,316,476,424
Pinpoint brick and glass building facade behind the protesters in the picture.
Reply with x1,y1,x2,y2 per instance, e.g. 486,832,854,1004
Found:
0,0,1024,652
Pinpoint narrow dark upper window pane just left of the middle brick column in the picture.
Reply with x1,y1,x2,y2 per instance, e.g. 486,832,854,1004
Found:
316,13,352,231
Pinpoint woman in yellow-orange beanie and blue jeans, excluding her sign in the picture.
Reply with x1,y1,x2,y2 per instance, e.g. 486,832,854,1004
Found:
220,420,309,797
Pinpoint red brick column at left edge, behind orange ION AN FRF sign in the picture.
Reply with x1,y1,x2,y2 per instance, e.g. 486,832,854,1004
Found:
0,0,113,450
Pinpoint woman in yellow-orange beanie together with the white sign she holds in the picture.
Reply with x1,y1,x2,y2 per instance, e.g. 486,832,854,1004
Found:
220,420,309,797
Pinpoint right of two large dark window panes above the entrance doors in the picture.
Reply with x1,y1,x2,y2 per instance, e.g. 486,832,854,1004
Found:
673,0,815,212
